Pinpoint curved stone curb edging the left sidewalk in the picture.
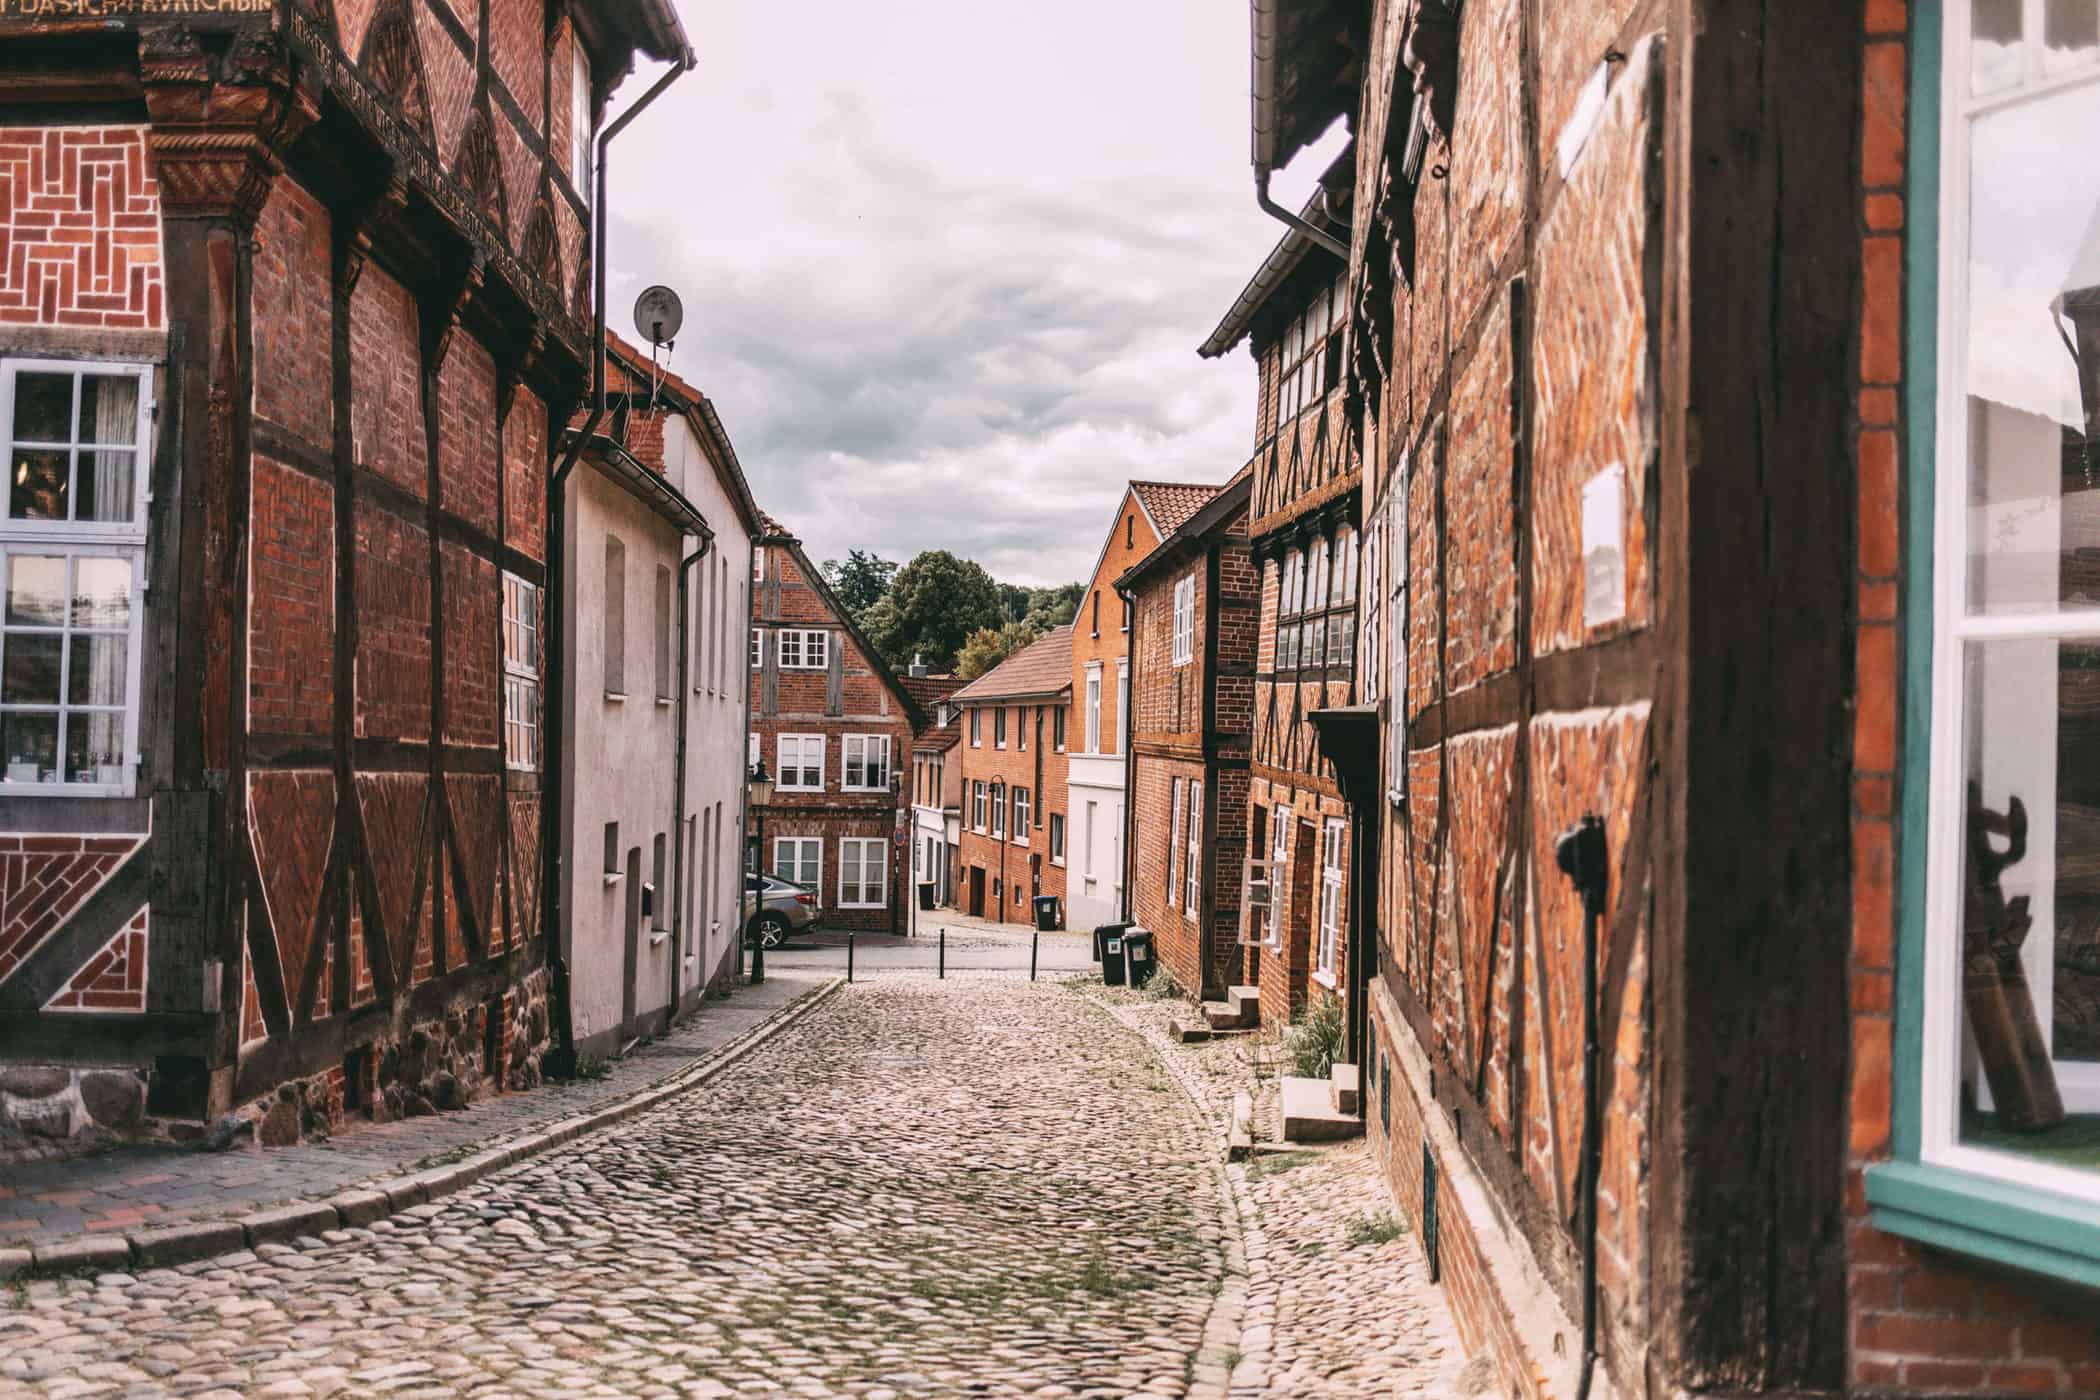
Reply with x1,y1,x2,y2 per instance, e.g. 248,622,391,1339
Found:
16,978,846,1280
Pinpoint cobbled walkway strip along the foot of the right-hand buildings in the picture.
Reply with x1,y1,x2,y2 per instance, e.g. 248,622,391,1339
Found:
1075,984,1489,1400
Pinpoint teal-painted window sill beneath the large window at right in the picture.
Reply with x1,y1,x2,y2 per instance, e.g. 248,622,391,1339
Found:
1867,1163,2100,1289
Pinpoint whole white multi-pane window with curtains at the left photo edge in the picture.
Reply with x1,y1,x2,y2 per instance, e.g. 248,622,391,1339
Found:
0,359,151,796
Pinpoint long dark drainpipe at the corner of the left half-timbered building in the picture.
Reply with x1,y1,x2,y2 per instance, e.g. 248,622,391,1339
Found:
540,48,699,1079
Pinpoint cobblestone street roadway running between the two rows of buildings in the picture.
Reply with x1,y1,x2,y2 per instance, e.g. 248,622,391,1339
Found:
0,976,1447,1398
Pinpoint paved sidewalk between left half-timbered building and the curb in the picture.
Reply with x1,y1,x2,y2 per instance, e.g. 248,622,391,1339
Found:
0,970,830,1249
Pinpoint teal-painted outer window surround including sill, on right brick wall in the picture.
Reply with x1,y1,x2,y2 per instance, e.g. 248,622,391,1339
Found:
1867,0,2100,1287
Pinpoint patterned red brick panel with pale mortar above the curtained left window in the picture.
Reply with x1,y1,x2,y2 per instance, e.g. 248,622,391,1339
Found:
0,126,166,330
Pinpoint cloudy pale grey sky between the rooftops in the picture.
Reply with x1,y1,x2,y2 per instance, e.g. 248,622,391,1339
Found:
607,0,1331,584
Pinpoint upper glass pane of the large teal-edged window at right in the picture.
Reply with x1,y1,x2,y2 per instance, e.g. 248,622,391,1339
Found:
1966,84,2100,613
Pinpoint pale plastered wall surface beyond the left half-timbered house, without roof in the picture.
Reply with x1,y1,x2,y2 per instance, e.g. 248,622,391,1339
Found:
561,418,752,1056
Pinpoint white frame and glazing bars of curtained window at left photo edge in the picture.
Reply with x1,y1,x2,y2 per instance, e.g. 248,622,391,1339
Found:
0,357,155,798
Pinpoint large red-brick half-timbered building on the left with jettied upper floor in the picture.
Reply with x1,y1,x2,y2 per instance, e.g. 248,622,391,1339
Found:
0,0,691,1142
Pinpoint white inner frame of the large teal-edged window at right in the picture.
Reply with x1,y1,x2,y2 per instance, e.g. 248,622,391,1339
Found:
1923,0,2100,1201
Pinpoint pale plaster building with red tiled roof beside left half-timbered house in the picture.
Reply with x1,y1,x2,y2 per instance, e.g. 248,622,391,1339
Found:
561,340,760,1058
